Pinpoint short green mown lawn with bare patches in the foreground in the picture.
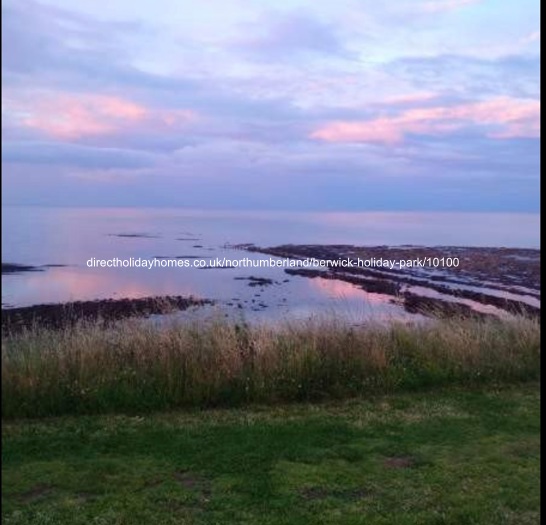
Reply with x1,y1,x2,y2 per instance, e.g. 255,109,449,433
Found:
2,382,540,525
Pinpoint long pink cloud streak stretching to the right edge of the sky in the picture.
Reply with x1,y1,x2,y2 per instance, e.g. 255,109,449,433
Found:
310,97,540,144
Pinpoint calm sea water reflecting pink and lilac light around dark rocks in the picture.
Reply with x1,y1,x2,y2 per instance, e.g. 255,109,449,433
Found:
2,207,539,319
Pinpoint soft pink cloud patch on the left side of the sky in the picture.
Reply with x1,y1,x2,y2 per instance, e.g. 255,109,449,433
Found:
6,93,197,140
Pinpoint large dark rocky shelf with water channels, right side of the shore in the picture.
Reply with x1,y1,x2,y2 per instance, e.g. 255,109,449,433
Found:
239,244,540,317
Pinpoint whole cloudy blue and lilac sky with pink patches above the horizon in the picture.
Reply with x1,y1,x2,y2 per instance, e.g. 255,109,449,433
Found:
2,0,540,213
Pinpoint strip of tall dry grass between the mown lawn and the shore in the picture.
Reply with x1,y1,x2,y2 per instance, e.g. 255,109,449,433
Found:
2,317,540,418
